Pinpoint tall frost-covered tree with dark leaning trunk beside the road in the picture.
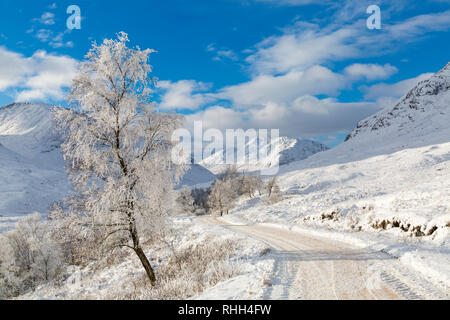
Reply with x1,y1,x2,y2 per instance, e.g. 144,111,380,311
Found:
55,32,183,285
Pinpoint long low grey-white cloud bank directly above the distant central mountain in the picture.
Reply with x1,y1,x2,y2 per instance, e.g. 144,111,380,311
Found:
187,95,379,137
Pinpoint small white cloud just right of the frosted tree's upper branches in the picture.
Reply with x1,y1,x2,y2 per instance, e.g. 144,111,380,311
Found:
158,80,211,110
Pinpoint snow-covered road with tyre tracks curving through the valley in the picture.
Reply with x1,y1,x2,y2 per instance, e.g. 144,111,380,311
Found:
200,217,449,299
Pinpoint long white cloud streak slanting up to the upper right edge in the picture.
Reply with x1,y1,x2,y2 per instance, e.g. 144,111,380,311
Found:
246,10,450,74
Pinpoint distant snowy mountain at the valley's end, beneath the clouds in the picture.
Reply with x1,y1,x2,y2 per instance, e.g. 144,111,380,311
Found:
200,137,328,174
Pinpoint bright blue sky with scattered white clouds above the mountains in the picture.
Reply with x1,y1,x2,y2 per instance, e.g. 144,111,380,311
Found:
0,0,450,146
